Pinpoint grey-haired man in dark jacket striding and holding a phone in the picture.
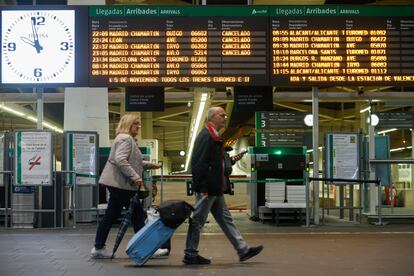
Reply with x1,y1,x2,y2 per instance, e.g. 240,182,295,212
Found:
183,107,263,265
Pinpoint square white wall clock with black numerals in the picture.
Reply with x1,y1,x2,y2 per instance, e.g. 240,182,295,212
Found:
1,10,75,84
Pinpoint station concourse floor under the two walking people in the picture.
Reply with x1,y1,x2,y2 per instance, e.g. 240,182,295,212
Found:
0,214,414,276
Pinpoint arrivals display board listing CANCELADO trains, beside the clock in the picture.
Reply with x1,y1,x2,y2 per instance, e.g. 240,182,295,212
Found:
89,6,269,86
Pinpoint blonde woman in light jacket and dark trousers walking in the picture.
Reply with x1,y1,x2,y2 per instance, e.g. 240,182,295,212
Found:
91,114,160,258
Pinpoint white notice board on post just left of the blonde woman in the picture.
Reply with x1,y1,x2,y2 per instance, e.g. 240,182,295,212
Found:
62,131,99,186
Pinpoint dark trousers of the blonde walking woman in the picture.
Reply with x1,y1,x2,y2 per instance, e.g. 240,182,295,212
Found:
95,186,147,249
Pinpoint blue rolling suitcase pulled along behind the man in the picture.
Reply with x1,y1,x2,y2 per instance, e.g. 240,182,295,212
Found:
126,218,174,266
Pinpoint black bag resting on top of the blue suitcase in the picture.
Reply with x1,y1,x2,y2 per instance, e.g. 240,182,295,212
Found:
158,200,194,229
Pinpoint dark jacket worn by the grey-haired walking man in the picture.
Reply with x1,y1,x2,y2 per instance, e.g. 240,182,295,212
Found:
191,128,224,196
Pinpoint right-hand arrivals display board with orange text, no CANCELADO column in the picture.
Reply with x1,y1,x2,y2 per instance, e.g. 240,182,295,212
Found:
269,6,414,86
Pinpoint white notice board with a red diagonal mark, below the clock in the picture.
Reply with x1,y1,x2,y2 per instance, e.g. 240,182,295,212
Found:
13,130,54,186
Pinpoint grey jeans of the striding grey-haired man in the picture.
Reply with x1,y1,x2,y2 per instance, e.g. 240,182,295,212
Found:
184,194,249,258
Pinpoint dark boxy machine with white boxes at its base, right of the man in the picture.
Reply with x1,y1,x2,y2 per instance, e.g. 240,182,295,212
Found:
247,147,307,223
